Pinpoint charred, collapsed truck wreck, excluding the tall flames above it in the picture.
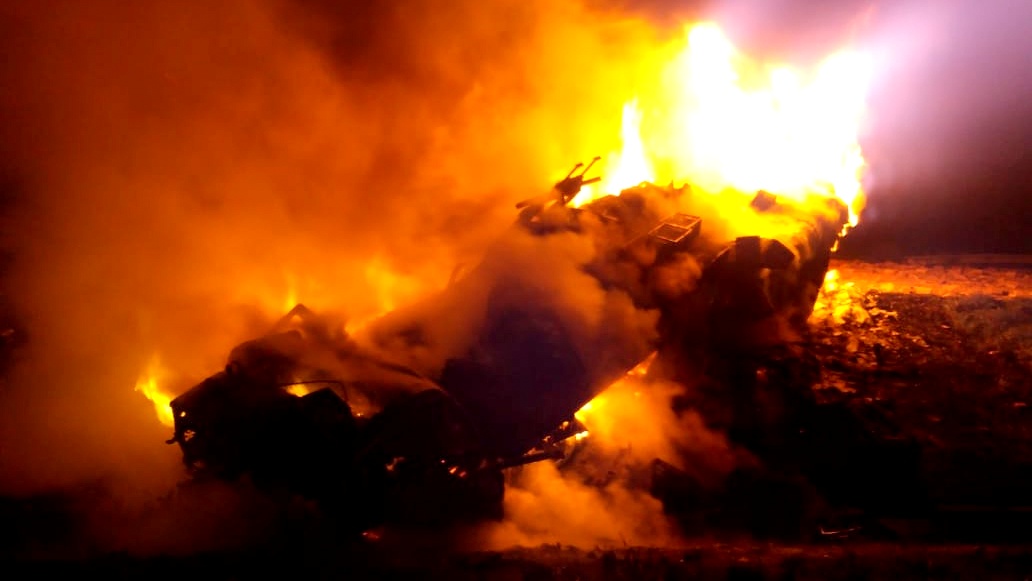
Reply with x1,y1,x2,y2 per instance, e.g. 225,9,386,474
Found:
168,162,847,530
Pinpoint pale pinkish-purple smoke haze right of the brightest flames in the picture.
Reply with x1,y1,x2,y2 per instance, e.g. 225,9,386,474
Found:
714,0,1032,256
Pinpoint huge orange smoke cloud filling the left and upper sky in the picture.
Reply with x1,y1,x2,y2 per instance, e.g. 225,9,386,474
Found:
0,0,875,553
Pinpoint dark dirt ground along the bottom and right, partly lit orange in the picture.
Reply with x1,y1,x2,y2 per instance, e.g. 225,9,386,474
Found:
0,257,1032,579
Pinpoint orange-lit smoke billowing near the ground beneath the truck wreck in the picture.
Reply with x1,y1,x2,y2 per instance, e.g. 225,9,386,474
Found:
474,376,753,550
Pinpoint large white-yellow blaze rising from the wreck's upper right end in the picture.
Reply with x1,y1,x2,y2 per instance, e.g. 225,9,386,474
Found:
576,24,868,225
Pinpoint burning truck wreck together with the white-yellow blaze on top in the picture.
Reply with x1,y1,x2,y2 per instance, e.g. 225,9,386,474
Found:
145,24,879,540
